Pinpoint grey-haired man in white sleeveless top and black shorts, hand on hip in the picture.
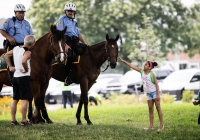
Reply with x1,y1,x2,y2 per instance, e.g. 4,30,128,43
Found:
5,35,35,126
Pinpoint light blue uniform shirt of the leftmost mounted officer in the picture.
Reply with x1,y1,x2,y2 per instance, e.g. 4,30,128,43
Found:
0,18,33,43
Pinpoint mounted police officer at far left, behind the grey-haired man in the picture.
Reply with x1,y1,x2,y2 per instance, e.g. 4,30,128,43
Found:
0,4,33,83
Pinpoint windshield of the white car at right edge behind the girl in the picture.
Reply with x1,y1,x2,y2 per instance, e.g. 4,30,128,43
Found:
165,72,193,82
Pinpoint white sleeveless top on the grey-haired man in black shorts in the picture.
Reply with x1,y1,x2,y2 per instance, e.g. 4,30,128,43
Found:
13,46,31,77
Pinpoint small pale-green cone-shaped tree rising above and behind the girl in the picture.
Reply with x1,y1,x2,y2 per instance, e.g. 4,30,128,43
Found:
128,13,164,67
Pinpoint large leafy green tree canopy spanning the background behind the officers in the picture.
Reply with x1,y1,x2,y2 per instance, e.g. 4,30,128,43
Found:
27,0,200,72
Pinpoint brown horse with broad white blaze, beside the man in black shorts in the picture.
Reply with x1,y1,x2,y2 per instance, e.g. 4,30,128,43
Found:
0,25,66,123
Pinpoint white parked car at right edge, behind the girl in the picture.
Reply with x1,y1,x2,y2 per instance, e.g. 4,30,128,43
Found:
160,69,200,100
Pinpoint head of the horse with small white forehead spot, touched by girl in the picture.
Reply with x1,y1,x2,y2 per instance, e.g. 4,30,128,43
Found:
105,34,119,69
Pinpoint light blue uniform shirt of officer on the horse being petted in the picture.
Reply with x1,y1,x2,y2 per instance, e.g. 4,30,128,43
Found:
56,15,80,37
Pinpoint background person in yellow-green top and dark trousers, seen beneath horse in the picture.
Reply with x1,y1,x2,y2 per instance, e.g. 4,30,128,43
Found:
62,82,73,108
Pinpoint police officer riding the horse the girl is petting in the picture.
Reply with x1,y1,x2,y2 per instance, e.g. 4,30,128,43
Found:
56,2,87,85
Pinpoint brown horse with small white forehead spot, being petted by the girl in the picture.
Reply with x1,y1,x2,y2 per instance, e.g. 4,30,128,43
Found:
45,35,119,125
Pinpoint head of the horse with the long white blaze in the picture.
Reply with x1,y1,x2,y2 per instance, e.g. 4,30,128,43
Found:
50,25,66,64
